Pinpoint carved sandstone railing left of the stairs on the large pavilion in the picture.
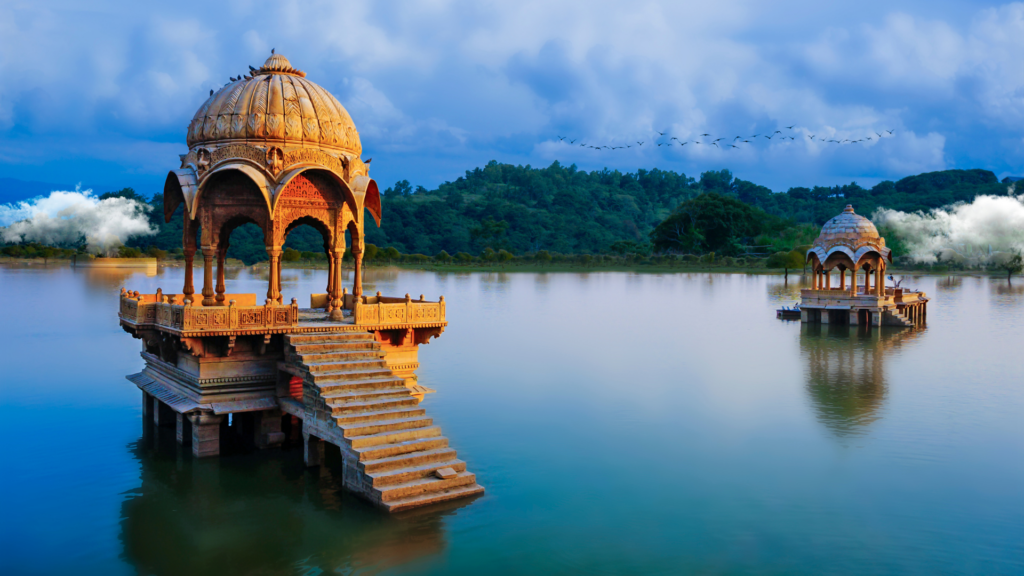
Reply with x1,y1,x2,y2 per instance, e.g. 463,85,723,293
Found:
118,292,299,333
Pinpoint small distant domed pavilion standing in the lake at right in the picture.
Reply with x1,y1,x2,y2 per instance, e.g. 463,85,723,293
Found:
800,205,928,326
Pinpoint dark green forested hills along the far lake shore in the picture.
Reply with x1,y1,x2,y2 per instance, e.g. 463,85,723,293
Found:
6,161,1009,263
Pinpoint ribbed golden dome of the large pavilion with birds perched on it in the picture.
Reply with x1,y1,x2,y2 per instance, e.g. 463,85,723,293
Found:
186,54,362,157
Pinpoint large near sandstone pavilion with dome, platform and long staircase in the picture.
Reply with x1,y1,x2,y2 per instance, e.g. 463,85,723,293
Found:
118,54,483,511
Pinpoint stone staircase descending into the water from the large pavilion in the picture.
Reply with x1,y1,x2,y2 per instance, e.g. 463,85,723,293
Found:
286,332,483,511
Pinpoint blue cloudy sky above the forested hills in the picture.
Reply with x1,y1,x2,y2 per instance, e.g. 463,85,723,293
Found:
0,0,1024,195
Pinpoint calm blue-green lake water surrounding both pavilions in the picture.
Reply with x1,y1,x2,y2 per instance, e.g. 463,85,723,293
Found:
0,266,1024,575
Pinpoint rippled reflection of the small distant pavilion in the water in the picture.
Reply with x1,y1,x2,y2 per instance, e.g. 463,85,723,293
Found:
800,324,921,437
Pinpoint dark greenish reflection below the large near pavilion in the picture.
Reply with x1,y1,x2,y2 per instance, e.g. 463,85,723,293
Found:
121,420,458,575
